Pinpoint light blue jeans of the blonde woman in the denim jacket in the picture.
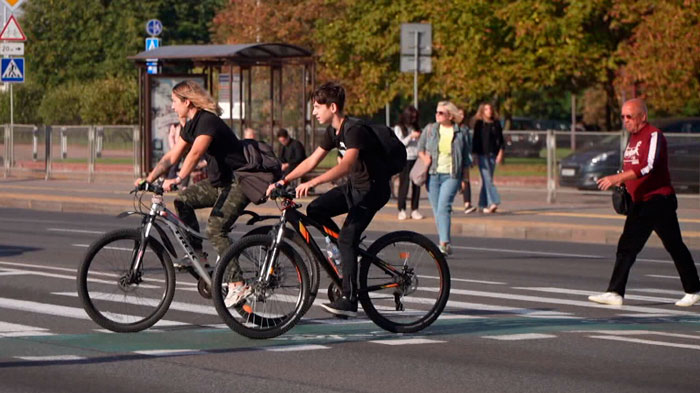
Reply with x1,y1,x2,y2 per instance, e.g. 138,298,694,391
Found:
428,174,460,243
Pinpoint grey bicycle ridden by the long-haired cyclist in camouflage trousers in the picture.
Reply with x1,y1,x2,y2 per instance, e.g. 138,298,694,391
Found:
77,182,304,332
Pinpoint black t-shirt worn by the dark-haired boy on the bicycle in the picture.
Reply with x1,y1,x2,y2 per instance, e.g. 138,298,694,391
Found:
319,118,389,190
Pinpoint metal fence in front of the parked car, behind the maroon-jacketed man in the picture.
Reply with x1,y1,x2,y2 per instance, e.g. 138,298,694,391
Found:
508,130,700,203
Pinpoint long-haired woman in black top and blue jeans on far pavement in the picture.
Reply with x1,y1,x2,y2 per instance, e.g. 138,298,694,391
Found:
472,103,505,213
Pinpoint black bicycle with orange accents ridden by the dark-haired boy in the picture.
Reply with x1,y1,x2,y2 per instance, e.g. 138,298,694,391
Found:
212,187,450,339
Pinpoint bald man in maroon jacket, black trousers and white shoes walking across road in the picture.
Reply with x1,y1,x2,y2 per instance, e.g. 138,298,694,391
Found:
588,98,700,307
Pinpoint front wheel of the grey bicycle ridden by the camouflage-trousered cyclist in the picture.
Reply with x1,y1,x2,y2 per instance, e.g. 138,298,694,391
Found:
77,229,175,332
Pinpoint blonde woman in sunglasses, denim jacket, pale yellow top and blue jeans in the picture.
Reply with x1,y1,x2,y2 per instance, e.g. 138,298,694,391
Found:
418,101,471,255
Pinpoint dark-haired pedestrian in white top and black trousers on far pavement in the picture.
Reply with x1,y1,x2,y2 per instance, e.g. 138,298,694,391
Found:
394,105,423,220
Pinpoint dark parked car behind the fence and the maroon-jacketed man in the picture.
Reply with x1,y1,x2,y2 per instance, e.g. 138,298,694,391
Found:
559,117,700,192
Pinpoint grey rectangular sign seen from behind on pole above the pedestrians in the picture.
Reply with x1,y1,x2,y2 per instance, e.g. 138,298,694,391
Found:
400,23,433,109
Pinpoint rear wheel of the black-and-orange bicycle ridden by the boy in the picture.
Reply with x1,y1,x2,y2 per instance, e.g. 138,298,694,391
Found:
358,231,450,333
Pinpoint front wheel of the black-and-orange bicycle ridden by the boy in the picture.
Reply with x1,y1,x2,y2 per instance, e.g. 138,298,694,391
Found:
212,235,309,339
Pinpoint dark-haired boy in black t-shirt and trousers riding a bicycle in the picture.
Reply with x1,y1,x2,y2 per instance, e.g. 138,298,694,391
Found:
268,82,391,316
